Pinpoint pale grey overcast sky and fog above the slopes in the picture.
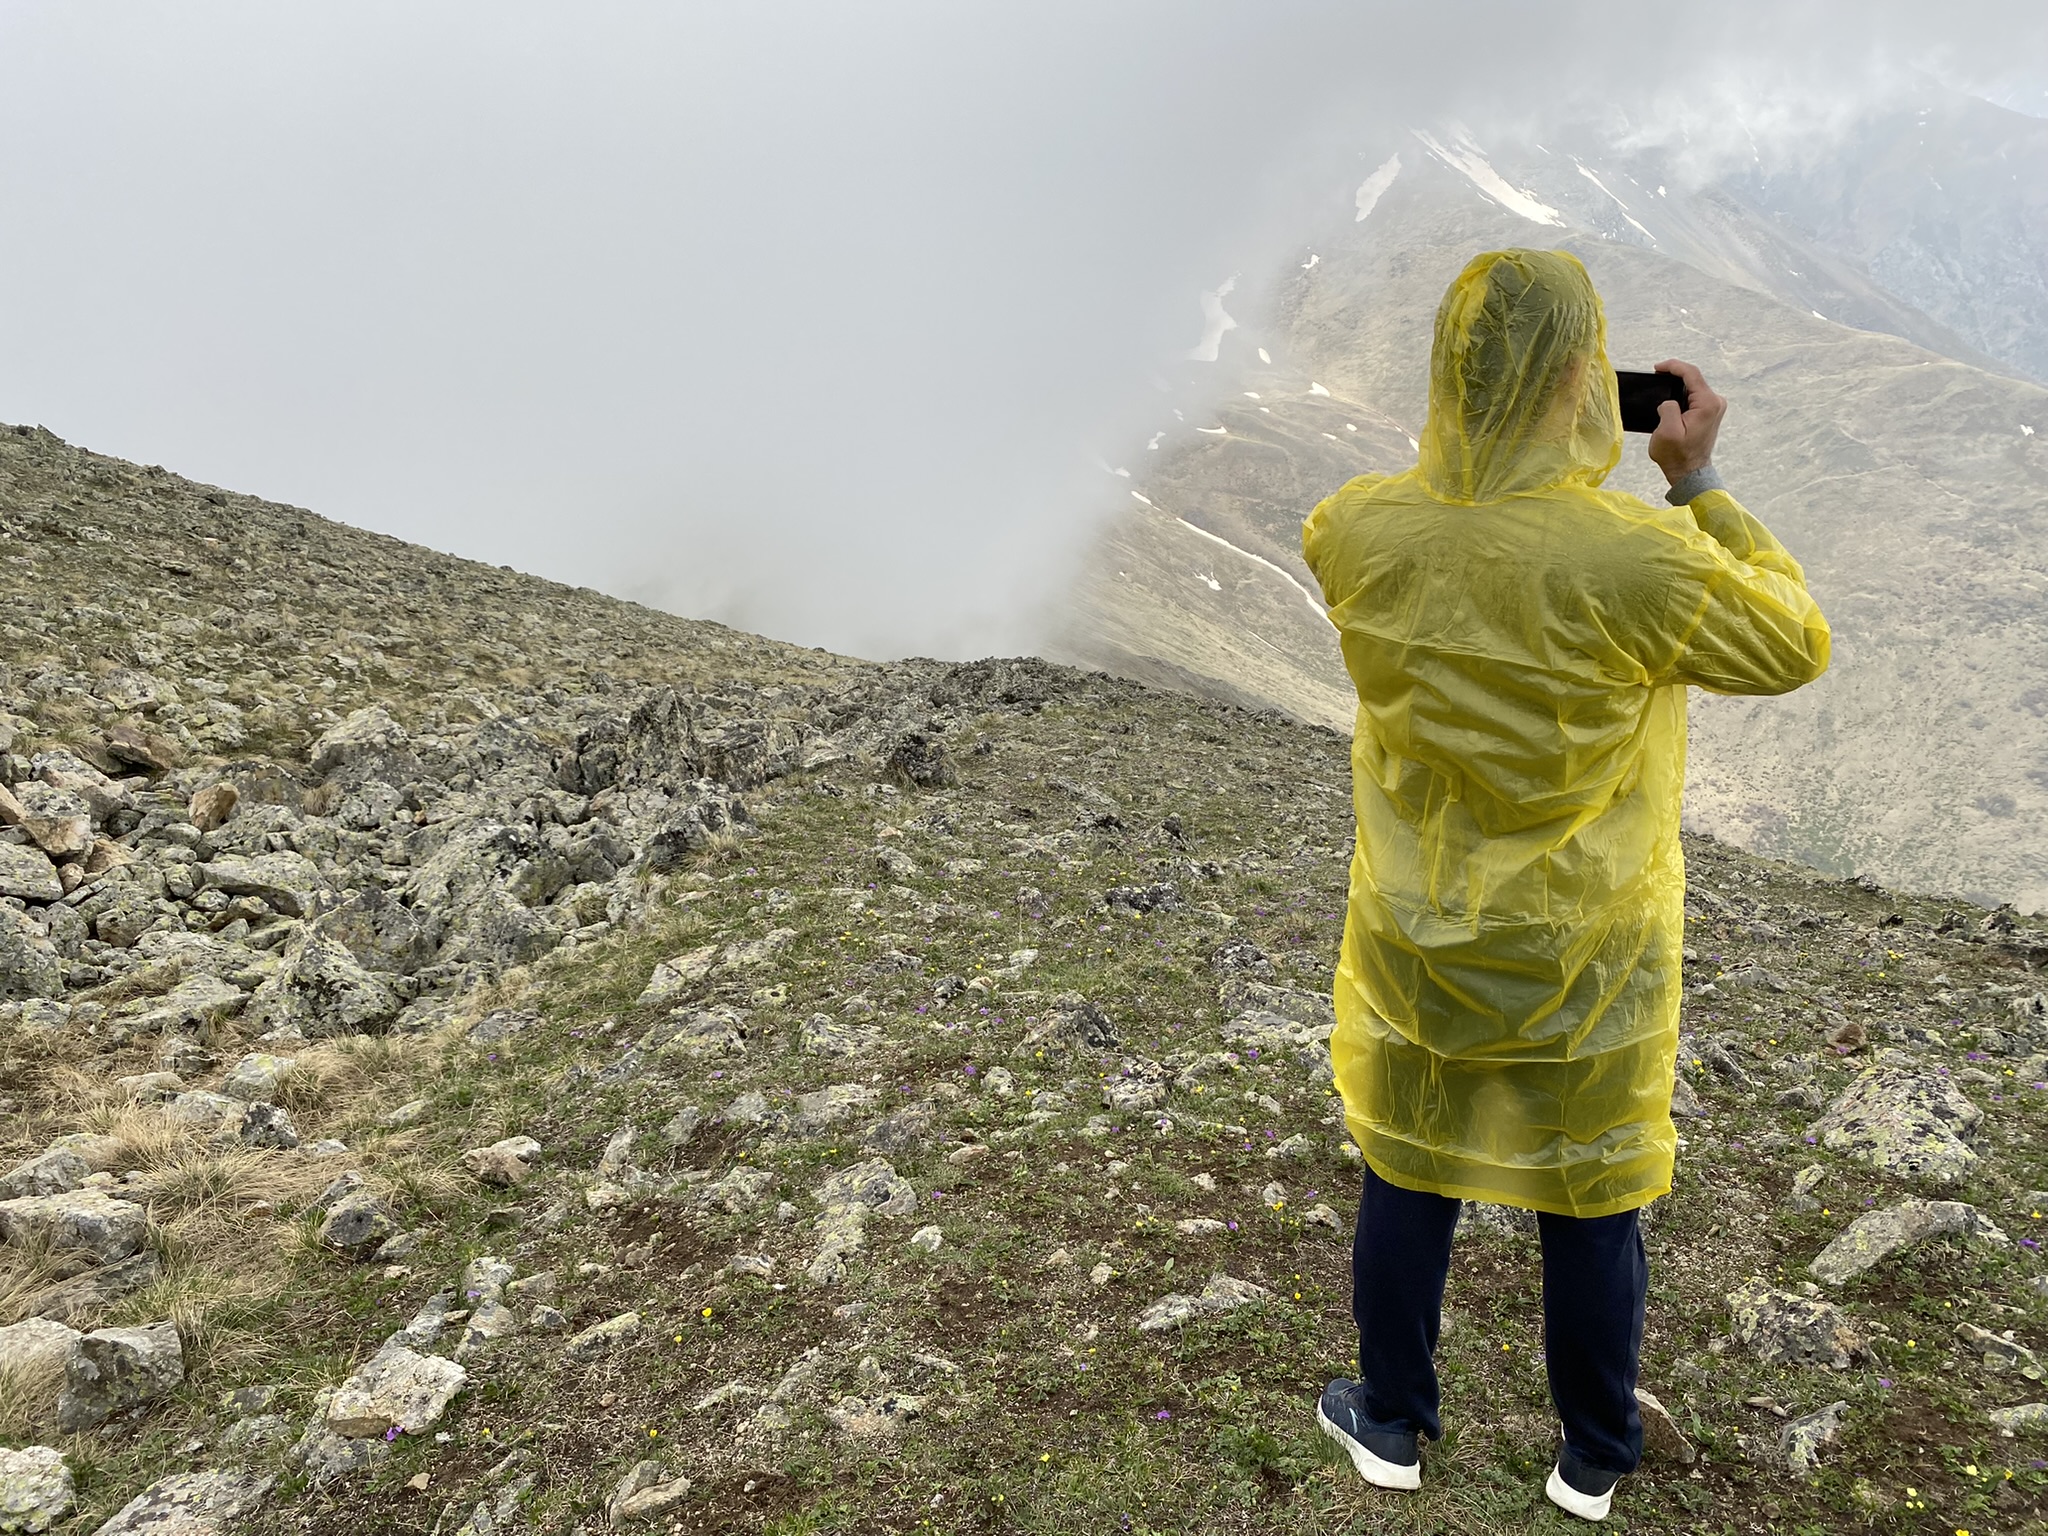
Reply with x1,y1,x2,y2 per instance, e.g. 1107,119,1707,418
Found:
0,0,2048,655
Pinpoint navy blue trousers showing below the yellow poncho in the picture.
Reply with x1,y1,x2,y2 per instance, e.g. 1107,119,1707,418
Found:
1352,1167,1649,1473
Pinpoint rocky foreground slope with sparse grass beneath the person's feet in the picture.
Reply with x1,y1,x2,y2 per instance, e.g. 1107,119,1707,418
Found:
0,423,2048,1536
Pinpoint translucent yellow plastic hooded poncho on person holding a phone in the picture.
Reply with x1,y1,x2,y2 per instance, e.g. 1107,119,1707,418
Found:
1303,250,1829,1217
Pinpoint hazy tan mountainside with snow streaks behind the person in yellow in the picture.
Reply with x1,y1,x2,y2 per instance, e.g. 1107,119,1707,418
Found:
1059,123,2048,909
